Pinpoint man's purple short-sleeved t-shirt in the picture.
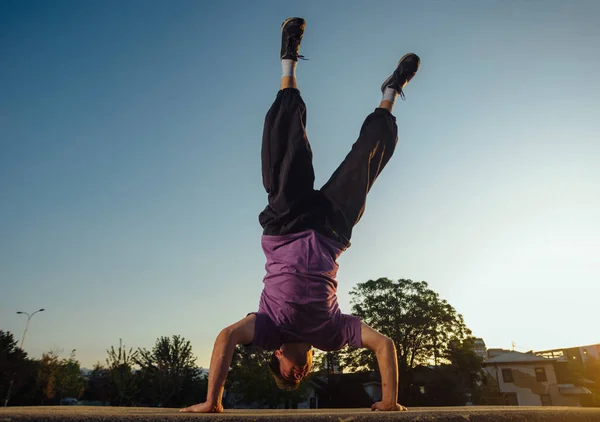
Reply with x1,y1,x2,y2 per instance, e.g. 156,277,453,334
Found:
251,230,362,351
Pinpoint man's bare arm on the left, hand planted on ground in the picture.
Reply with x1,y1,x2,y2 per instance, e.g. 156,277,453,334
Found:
181,314,256,413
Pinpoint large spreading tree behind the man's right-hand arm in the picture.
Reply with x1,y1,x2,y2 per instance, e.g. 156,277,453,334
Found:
342,278,471,395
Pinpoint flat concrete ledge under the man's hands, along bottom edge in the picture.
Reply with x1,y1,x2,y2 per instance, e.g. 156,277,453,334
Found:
0,406,600,422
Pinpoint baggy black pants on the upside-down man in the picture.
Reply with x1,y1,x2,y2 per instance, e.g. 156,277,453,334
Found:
259,88,398,246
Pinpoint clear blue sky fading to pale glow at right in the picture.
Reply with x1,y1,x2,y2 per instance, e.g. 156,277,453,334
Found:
0,0,600,367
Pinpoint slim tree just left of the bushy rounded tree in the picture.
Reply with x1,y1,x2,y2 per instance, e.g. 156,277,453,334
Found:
106,339,138,406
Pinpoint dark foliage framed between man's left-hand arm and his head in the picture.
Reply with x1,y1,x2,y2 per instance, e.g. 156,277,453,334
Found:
226,346,310,409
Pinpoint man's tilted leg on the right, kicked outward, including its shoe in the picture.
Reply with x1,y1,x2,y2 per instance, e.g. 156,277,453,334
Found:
321,54,420,244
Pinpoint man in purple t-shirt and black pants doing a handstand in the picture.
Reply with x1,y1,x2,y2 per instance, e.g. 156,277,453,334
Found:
182,18,420,412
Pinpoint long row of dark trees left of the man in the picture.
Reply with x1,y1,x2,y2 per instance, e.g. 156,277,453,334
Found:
0,330,208,407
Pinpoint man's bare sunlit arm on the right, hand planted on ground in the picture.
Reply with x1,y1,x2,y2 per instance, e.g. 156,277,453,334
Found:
360,322,406,410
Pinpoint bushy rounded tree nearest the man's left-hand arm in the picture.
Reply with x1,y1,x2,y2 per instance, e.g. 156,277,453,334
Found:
134,335,196,407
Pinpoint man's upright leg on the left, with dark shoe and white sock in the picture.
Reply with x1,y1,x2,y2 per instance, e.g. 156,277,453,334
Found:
259,18,315,235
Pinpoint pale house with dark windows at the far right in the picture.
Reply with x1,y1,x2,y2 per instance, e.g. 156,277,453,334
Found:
483,349,591,406
